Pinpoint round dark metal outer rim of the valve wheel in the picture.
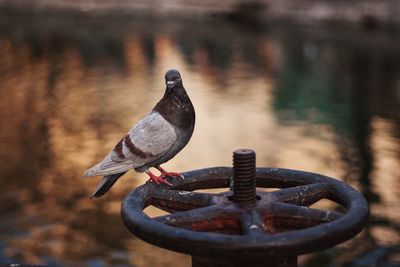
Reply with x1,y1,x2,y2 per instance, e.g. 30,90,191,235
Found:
121,167,369,257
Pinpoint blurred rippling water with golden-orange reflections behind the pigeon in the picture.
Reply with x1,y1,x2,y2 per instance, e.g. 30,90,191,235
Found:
0,11,400,266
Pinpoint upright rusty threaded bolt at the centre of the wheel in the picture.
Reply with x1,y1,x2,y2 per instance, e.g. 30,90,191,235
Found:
233,149,256,205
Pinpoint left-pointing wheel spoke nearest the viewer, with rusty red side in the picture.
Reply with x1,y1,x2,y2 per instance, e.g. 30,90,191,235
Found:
153,205,239,233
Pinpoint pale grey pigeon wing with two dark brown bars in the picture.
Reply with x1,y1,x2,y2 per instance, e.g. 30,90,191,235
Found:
84,112,177,176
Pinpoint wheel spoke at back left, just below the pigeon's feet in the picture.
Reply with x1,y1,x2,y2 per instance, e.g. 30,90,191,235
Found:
148,190,216,213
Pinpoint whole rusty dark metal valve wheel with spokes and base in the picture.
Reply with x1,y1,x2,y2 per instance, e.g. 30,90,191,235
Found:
121,150,369,267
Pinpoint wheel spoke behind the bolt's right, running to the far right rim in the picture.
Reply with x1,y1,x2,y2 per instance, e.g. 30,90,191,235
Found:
271,183,331,206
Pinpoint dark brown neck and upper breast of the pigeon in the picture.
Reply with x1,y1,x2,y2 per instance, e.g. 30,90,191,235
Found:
153,86,195,129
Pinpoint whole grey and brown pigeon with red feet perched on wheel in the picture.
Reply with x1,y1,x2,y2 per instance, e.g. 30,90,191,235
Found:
83,70,195,198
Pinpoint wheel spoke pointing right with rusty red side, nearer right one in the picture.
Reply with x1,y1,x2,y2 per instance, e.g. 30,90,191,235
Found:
260,202,343,230
